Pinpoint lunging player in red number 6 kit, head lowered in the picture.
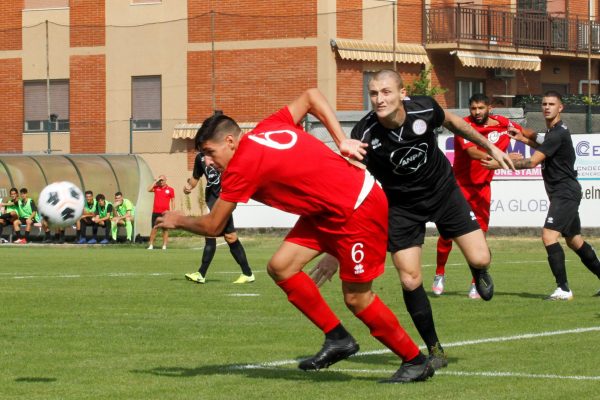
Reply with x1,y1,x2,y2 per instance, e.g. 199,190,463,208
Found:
158,89,434,383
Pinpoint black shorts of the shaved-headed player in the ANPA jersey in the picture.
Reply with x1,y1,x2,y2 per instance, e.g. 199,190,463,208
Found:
388,186,481,253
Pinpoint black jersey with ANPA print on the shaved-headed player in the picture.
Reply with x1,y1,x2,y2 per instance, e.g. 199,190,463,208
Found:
351,96,457,213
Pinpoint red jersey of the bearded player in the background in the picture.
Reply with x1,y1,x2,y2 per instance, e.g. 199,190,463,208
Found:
453,115,521,186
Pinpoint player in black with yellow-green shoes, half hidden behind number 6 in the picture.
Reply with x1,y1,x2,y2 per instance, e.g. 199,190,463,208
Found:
183,153,255,283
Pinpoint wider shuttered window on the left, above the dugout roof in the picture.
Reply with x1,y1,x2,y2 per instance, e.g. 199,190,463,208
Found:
23,80,69,132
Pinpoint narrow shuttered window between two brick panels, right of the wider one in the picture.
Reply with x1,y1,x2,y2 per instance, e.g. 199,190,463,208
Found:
131,76,162,131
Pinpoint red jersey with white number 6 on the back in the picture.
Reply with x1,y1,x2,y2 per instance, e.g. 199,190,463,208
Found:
220,107,370,222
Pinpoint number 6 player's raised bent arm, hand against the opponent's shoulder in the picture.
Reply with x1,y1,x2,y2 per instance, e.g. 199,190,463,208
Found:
288,88,367,160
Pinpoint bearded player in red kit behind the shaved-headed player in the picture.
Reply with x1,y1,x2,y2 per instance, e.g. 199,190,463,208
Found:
432,93,522,299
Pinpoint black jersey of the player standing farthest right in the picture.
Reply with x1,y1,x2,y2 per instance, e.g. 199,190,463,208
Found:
536,121,581,200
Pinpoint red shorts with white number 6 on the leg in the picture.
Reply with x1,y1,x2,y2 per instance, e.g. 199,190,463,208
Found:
285,185,388,283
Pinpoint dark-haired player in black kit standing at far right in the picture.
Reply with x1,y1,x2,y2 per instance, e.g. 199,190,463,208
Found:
483,91,600,300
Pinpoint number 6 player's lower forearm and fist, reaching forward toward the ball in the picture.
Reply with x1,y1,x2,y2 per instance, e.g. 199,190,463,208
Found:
156,198,237,237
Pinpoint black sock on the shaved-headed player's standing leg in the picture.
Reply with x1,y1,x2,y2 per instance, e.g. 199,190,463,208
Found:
402,285,443,352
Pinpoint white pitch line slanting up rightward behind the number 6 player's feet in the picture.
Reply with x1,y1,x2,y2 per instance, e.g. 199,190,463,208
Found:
232,326,600,369
